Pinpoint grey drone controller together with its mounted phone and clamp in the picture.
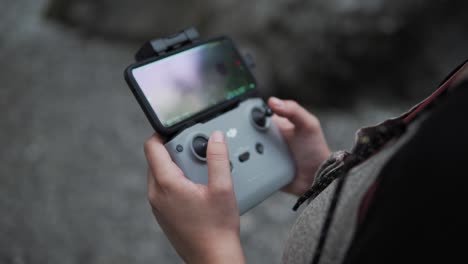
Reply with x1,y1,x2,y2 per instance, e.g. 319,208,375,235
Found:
125,28,295,214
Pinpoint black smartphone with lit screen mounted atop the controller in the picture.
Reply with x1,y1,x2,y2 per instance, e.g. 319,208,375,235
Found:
125,37,258,137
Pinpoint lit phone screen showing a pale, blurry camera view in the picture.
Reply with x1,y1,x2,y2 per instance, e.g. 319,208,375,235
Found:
132,39,256,127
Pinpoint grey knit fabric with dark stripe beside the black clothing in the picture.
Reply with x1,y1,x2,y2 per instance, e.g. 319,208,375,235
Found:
283,120,421,264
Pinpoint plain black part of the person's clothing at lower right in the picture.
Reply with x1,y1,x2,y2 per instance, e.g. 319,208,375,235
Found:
347,81,468,263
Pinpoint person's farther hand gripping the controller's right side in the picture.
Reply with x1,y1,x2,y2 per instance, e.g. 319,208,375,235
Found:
268,97,330,196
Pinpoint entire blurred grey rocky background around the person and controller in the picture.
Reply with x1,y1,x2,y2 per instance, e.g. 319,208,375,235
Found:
0,0,468,263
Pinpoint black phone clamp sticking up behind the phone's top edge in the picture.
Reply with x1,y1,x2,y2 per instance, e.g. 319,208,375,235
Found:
135,27,200,62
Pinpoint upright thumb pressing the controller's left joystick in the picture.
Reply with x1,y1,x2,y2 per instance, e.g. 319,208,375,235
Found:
206,131,233,191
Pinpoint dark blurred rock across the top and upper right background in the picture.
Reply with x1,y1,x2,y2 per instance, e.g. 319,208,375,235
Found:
48,0,468,107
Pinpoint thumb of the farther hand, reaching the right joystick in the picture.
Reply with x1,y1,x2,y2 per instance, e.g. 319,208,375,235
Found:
268,97,320,130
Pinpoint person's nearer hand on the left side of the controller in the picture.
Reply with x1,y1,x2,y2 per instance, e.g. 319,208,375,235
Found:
145,132,245,263
